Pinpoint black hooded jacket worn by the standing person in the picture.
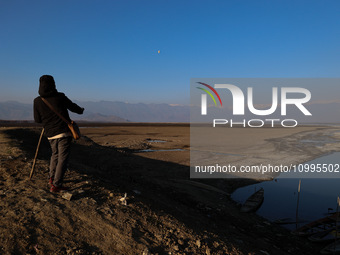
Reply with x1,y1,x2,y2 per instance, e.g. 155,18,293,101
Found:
33,75,84,137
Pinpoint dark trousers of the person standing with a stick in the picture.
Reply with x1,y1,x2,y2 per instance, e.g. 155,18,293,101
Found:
49,137,72,187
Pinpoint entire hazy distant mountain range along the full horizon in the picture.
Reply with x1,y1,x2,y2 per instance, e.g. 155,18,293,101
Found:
0,101,340,123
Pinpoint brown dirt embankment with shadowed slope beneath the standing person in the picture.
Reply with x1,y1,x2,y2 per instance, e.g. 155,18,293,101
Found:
0,128,320,254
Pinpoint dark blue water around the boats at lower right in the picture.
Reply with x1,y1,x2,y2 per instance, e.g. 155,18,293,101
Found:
232,152,340,228
